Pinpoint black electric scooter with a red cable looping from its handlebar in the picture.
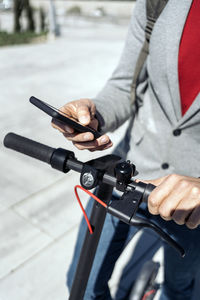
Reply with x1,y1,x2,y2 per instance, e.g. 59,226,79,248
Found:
4,133,185,300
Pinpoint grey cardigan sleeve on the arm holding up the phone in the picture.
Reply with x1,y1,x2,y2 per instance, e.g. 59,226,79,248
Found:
93,0,146,133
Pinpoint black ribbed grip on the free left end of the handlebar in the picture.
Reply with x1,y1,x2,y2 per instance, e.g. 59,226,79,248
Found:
4,132,55,164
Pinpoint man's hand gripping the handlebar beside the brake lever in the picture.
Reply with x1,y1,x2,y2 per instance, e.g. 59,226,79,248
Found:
142,174,200,229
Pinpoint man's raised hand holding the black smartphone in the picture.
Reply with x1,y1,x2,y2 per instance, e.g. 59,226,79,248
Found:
52,99,112,151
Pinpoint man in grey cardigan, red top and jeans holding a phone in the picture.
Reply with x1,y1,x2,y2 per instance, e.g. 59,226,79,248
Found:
53,0,200,300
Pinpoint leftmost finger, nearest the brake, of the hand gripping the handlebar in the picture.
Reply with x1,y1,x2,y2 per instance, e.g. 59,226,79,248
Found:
148,174,180,215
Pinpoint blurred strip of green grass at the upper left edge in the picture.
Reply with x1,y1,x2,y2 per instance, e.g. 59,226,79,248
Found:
0,31,47,47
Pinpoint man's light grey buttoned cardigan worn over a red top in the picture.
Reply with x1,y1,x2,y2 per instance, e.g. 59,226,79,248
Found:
94,0,200,179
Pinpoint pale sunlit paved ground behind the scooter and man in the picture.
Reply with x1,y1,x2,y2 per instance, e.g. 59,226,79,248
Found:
0,17,166,300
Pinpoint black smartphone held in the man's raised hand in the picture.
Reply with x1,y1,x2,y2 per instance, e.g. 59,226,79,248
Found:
29,96,101,139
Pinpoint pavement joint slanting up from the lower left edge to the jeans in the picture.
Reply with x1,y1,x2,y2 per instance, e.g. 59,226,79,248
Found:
0,223,79,282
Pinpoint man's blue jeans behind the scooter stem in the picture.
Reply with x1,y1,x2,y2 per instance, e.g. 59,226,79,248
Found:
67,195,200,300
